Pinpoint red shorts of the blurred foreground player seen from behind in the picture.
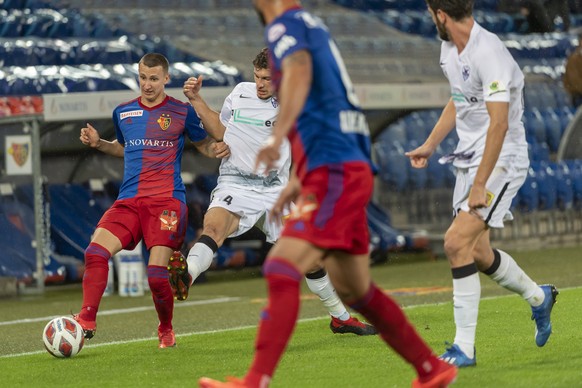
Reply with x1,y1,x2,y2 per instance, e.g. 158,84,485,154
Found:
282,162,374,255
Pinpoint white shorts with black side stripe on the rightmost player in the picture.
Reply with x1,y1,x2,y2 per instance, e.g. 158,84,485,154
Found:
453,161,527,228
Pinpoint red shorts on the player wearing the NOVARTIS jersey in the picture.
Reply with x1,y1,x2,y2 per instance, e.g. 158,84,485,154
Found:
97,197,188,250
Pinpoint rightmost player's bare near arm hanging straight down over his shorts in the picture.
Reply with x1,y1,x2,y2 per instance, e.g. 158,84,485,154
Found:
469,101,509,209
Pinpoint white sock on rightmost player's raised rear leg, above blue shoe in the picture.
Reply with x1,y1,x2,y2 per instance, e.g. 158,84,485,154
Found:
490,249,544,307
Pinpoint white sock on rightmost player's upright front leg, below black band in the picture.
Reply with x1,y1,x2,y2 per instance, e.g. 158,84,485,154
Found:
453,273,481,358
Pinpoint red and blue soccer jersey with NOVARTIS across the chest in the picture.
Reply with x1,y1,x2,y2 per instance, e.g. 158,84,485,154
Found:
113,96,207,202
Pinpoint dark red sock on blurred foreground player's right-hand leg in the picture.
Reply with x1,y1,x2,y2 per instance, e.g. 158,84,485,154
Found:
350,283,438,377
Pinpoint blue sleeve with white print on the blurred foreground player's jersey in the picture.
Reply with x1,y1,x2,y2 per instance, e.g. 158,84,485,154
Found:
265,13,309,69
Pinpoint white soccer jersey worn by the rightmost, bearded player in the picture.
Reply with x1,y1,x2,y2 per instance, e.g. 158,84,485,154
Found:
440,22,529,167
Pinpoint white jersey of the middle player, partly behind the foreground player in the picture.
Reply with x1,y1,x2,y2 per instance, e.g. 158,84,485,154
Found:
218,82,291,192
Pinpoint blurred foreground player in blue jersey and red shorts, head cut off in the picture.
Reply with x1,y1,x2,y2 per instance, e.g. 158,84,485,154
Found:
199,0,457,388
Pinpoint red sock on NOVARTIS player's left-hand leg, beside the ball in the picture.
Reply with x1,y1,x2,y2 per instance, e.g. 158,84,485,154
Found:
79,242,111,321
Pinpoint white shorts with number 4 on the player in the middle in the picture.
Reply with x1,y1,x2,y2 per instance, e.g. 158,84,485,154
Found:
208,183,283,243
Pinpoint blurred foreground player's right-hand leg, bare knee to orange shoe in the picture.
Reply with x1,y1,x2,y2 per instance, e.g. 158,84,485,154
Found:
325,251,456,386
